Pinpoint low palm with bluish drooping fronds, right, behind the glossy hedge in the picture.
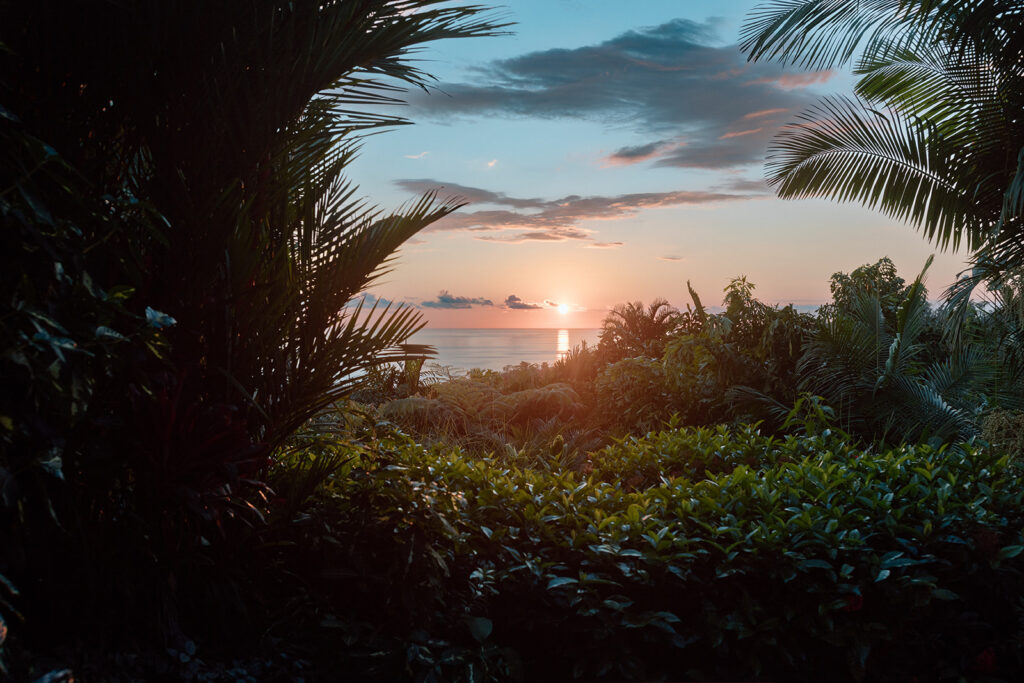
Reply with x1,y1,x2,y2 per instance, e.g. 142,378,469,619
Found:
730,259,1021,444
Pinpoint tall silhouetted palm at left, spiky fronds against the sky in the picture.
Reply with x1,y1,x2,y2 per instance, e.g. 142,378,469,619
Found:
0,0,498,449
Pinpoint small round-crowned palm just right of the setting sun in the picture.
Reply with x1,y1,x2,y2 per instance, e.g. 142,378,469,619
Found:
599,298,679,359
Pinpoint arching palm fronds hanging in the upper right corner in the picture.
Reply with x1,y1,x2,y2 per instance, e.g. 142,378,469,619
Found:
742,0,1024,310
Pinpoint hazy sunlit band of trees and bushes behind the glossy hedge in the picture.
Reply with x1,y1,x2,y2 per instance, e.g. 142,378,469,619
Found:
381,258,1024,462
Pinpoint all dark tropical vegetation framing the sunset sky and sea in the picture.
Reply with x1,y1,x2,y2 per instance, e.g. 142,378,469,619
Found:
0,0,1024,683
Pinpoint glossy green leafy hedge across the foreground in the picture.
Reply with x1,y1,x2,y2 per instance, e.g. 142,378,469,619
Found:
270,428,1024,681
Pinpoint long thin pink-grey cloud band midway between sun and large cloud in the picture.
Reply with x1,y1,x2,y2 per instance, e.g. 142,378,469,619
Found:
396,178,754,244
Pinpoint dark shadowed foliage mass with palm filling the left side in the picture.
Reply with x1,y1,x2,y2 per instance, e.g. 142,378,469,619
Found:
0,0,497,671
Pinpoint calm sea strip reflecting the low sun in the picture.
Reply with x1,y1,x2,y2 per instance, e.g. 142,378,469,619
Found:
410,328,600,371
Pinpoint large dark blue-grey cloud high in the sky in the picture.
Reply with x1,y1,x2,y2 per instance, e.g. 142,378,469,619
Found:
411,18,833,169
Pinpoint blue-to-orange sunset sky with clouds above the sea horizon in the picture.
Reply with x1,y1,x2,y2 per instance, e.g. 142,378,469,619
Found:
350,0,966,328
